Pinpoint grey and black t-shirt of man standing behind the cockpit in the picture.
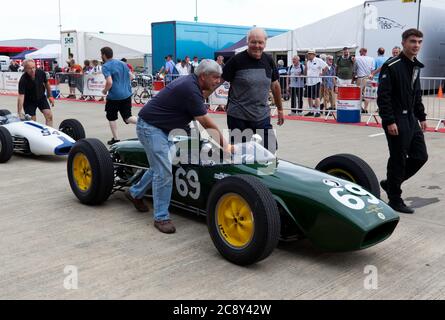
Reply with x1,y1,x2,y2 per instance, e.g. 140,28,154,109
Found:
222,50,279,121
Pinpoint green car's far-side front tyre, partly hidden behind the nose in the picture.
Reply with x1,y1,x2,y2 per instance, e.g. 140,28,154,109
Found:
315,154,380,198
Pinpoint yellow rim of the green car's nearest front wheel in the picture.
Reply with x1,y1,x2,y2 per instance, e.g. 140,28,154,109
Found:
216,193,255,249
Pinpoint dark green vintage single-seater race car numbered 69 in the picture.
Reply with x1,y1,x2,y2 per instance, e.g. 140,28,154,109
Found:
67,131,399,265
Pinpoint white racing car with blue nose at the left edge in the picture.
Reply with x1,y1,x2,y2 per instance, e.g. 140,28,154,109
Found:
0,110,85,163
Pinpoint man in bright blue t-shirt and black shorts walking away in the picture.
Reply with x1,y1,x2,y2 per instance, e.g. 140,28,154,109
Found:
100,47,137,145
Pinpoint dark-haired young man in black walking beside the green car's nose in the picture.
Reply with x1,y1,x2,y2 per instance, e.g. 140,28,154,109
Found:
377,29,428,214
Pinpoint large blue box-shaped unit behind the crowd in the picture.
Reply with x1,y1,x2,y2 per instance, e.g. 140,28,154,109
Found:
151,21,288,71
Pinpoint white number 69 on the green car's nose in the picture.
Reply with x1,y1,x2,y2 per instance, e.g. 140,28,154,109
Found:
329,184,380,210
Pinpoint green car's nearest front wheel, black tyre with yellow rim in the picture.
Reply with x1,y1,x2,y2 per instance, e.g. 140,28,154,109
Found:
207,175,281,266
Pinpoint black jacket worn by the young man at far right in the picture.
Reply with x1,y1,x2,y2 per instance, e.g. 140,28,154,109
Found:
377,52,426,127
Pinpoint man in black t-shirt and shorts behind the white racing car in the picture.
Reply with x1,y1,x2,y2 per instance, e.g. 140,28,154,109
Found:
17,59,54,127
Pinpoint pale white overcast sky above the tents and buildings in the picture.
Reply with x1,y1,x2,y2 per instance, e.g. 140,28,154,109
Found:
0,0,364,40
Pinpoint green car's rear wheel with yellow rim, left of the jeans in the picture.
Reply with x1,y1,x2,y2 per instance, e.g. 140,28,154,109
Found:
67,139,114,205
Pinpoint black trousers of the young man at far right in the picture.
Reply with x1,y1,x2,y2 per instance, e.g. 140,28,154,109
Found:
385,114,428,202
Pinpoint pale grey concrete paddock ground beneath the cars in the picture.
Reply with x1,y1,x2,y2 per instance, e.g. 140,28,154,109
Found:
0,96,445,299
